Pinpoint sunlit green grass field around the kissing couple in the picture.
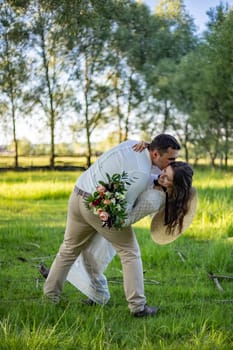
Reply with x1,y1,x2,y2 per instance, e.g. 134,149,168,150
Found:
0,170,233,350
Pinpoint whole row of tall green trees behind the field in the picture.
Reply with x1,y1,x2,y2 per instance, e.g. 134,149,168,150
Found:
0,0,233,168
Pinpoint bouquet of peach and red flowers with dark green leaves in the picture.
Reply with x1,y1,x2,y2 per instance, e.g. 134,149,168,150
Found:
86,171,130,229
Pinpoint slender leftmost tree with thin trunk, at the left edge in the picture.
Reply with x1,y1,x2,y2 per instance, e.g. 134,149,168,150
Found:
0,2,28,167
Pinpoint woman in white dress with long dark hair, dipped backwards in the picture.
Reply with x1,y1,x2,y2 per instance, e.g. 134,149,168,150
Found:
67,162,193,305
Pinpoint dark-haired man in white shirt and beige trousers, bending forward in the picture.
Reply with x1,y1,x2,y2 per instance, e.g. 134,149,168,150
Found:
44,134,180,317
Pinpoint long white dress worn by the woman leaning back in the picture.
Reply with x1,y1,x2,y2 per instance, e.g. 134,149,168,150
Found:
67,188,165,304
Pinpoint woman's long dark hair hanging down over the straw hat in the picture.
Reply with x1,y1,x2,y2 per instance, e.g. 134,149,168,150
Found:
165,162,193,234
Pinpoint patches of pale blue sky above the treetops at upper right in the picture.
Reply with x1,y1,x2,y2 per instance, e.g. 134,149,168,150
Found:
144,0,233,33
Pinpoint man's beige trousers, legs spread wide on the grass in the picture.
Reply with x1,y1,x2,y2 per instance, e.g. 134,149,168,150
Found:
44,192,146,312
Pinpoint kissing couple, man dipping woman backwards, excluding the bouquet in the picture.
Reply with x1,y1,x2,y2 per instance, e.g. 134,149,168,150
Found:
41,134,196,317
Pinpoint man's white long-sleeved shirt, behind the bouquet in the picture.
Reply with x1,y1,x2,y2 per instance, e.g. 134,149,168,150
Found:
76,141,152,210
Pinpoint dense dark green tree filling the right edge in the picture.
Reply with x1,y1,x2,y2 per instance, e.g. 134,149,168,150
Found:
187,5,233,166
